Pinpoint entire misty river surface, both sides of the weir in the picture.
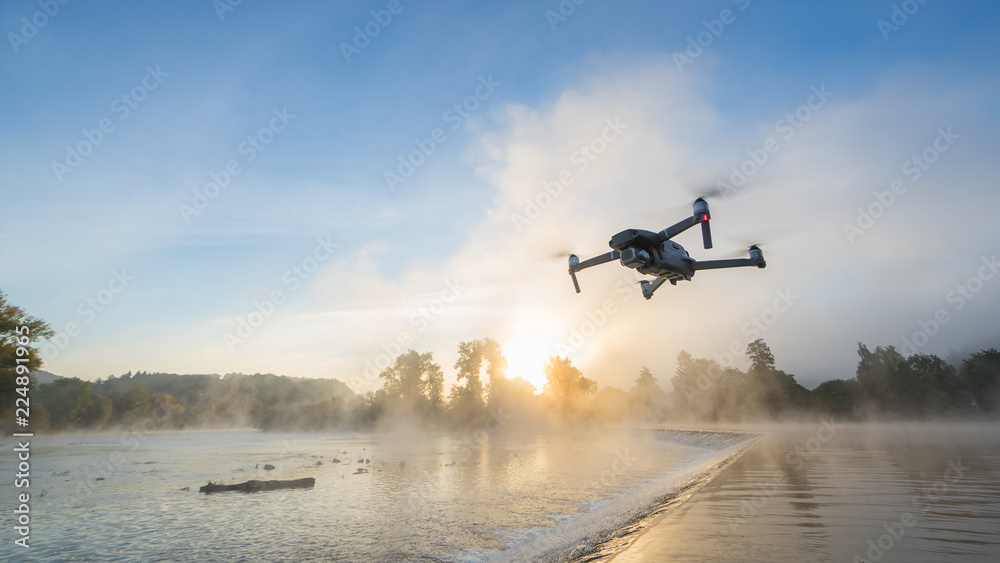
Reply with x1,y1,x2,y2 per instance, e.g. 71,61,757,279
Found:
0,424,1000,563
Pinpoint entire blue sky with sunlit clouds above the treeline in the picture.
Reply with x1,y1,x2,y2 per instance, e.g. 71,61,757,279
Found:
0,0,1000,392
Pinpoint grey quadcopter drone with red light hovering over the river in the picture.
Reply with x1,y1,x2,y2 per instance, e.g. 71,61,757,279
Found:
569,198,767,299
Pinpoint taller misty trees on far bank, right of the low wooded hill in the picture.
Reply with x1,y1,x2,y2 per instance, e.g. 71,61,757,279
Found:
350,338,1000,425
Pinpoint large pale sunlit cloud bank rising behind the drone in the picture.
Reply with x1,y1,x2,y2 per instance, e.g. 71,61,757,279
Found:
54,56,1000,391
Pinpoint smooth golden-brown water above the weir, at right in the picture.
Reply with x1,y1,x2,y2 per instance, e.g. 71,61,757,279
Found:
616,424,1000,563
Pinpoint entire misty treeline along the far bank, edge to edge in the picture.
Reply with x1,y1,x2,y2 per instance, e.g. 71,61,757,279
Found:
0,292,1000,431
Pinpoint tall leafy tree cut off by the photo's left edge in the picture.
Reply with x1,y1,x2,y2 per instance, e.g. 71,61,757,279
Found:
0,291,55,423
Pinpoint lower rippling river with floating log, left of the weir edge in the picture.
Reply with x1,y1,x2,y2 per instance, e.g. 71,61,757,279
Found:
0,430,746,561
